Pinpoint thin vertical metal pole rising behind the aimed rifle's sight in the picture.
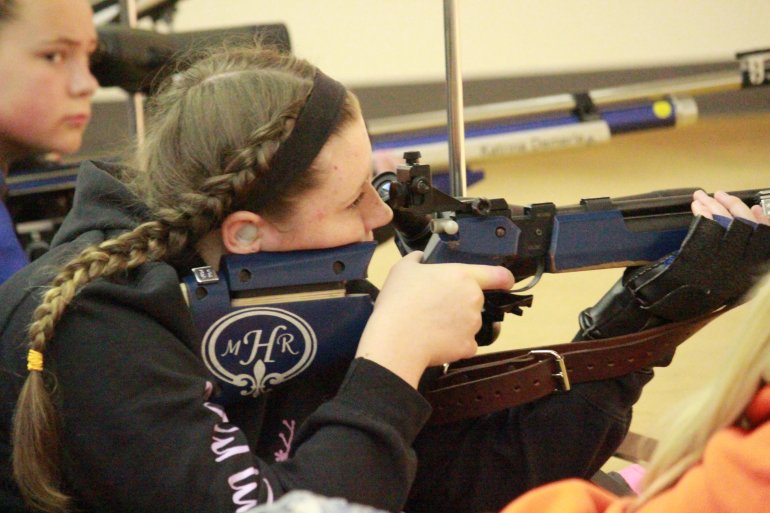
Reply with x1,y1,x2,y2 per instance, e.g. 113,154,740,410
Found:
444,0,467,197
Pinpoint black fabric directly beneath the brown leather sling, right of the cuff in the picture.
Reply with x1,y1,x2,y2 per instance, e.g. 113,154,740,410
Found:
405,372,652,513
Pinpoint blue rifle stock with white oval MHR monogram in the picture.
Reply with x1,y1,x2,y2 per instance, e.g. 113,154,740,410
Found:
182,242,377,403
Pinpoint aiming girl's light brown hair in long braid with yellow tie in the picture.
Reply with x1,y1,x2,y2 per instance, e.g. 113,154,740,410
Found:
12,45,359,513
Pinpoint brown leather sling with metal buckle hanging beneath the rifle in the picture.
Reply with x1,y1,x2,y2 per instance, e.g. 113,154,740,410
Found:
423,305,724,424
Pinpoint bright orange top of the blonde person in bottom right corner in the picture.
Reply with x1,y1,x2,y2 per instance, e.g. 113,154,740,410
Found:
501,385,770,513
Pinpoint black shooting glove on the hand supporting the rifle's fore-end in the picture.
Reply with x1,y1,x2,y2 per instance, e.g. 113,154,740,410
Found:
576,216,770,340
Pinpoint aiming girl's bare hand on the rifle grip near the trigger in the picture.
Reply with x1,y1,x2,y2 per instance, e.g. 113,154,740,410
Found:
357,251,514,388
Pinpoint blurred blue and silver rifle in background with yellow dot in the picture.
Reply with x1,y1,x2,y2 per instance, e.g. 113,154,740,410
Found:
367,46,770,169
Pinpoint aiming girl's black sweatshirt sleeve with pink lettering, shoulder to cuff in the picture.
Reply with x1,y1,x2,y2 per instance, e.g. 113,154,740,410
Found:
46,268,429,513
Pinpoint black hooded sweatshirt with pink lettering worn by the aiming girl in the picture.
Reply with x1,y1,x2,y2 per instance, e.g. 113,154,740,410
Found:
0,163,649,513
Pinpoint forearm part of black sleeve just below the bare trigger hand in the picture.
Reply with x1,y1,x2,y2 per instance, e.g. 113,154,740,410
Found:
276,358,430,511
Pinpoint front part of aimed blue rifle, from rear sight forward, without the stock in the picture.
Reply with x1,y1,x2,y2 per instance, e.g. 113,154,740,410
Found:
373,152,770,285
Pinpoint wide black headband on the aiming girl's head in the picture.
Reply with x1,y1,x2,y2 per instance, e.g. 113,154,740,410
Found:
270,70,347,184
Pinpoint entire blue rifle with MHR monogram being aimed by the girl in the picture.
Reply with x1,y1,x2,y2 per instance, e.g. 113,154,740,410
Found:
182,152,770,402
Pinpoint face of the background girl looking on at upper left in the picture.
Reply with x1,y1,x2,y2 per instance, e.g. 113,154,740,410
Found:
0,0,98,162
